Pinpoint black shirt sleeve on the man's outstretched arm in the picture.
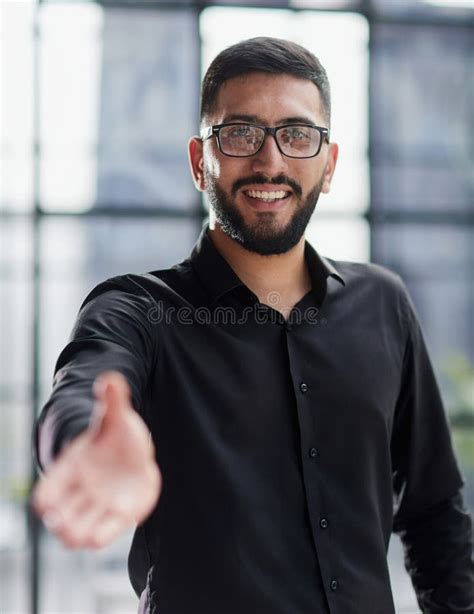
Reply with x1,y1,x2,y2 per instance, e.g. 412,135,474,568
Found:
34,276,157,469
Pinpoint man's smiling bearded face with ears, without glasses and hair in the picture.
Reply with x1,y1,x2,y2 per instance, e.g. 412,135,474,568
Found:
189,73,337,255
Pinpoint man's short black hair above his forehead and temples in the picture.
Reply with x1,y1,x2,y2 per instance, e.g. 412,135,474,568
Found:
200,36,331,126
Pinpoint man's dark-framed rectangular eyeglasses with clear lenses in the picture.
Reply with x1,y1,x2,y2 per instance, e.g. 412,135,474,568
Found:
201,124,329,158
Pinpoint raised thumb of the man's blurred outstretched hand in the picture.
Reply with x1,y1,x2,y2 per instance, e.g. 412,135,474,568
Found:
91,371,131,436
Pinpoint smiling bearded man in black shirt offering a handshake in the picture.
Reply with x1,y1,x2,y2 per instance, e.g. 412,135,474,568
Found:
34,38,474,614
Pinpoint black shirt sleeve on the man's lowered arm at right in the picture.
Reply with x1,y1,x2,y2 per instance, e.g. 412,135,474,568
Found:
392,282,474,614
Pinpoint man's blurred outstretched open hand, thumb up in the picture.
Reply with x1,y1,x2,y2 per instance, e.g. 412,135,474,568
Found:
32,371,161,548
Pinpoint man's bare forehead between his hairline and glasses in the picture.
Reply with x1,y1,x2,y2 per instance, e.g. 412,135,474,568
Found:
212,73,324,125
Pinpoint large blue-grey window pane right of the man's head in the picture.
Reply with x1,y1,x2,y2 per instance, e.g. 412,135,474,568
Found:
372,24,474,212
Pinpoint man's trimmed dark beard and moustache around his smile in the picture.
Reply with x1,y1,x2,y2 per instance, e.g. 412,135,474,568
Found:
205,170,324,256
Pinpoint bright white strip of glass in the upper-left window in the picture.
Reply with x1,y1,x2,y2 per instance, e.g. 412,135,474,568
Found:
40,4,103,210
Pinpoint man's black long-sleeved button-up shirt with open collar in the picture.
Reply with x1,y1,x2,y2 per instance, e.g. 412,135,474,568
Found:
38,228,474,614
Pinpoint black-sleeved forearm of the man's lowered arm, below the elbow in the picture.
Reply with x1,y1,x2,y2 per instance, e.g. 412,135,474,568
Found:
394,492,474,614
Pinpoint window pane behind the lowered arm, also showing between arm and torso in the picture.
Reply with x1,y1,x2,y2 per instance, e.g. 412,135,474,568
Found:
372,224,474,612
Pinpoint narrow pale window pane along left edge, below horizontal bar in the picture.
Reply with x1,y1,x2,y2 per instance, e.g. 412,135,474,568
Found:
0,218,33,613
